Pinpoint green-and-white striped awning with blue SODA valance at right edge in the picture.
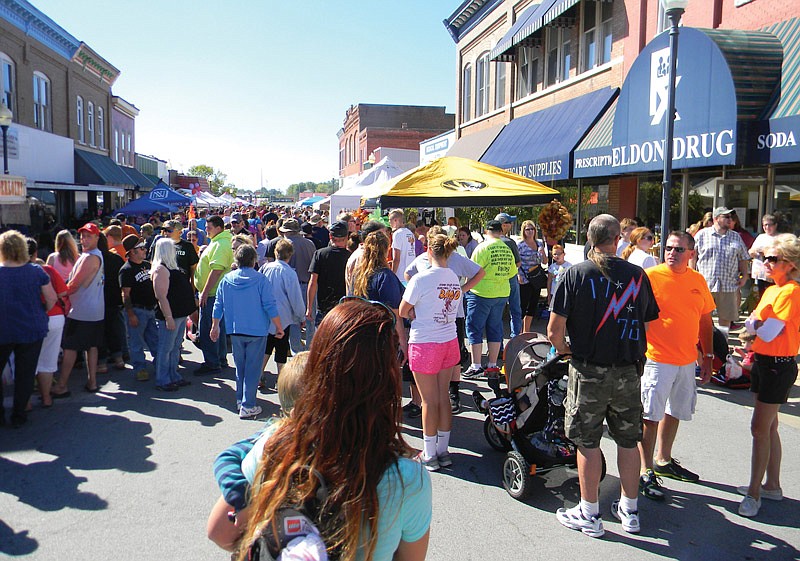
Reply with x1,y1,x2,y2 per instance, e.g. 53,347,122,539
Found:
746,18,800,165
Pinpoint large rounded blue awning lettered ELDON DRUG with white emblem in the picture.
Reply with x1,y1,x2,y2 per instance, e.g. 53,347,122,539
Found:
572,27,783,177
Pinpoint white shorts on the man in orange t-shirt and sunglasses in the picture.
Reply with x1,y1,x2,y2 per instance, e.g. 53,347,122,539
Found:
642,359,697,422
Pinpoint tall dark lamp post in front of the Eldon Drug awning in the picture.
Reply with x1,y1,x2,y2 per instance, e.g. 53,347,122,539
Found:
660,0,689,262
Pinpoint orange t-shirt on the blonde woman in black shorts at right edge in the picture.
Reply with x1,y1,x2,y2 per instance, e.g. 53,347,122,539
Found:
753,282,800,356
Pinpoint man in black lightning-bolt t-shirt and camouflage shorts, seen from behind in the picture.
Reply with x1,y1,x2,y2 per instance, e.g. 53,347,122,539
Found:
547,214,658,537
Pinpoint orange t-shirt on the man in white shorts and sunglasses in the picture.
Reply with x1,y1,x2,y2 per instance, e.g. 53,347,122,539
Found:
645,263,716,366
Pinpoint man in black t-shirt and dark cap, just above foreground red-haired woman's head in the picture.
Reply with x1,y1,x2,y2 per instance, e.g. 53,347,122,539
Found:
306,221,350,325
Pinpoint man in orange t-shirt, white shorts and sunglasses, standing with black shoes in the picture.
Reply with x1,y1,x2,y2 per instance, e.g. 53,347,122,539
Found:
639,232,716,501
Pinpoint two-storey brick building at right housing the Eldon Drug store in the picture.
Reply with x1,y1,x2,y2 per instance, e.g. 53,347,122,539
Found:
444,0,800,236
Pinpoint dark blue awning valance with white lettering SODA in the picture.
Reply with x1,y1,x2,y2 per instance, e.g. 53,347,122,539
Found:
747,115,800,164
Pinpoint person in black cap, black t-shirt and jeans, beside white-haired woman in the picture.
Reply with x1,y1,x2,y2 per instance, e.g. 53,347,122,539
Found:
119,235,158,382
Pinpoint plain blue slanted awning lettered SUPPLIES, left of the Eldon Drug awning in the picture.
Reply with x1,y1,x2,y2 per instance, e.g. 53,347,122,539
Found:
480,88,619,181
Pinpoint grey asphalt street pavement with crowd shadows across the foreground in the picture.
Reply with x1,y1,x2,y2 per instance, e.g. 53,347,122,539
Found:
0,325,800,561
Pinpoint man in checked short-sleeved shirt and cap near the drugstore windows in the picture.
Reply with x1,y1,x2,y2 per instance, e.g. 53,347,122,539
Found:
694,206,750,336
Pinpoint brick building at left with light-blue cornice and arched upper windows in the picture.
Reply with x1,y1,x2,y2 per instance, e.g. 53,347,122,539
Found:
0,0,152,230
